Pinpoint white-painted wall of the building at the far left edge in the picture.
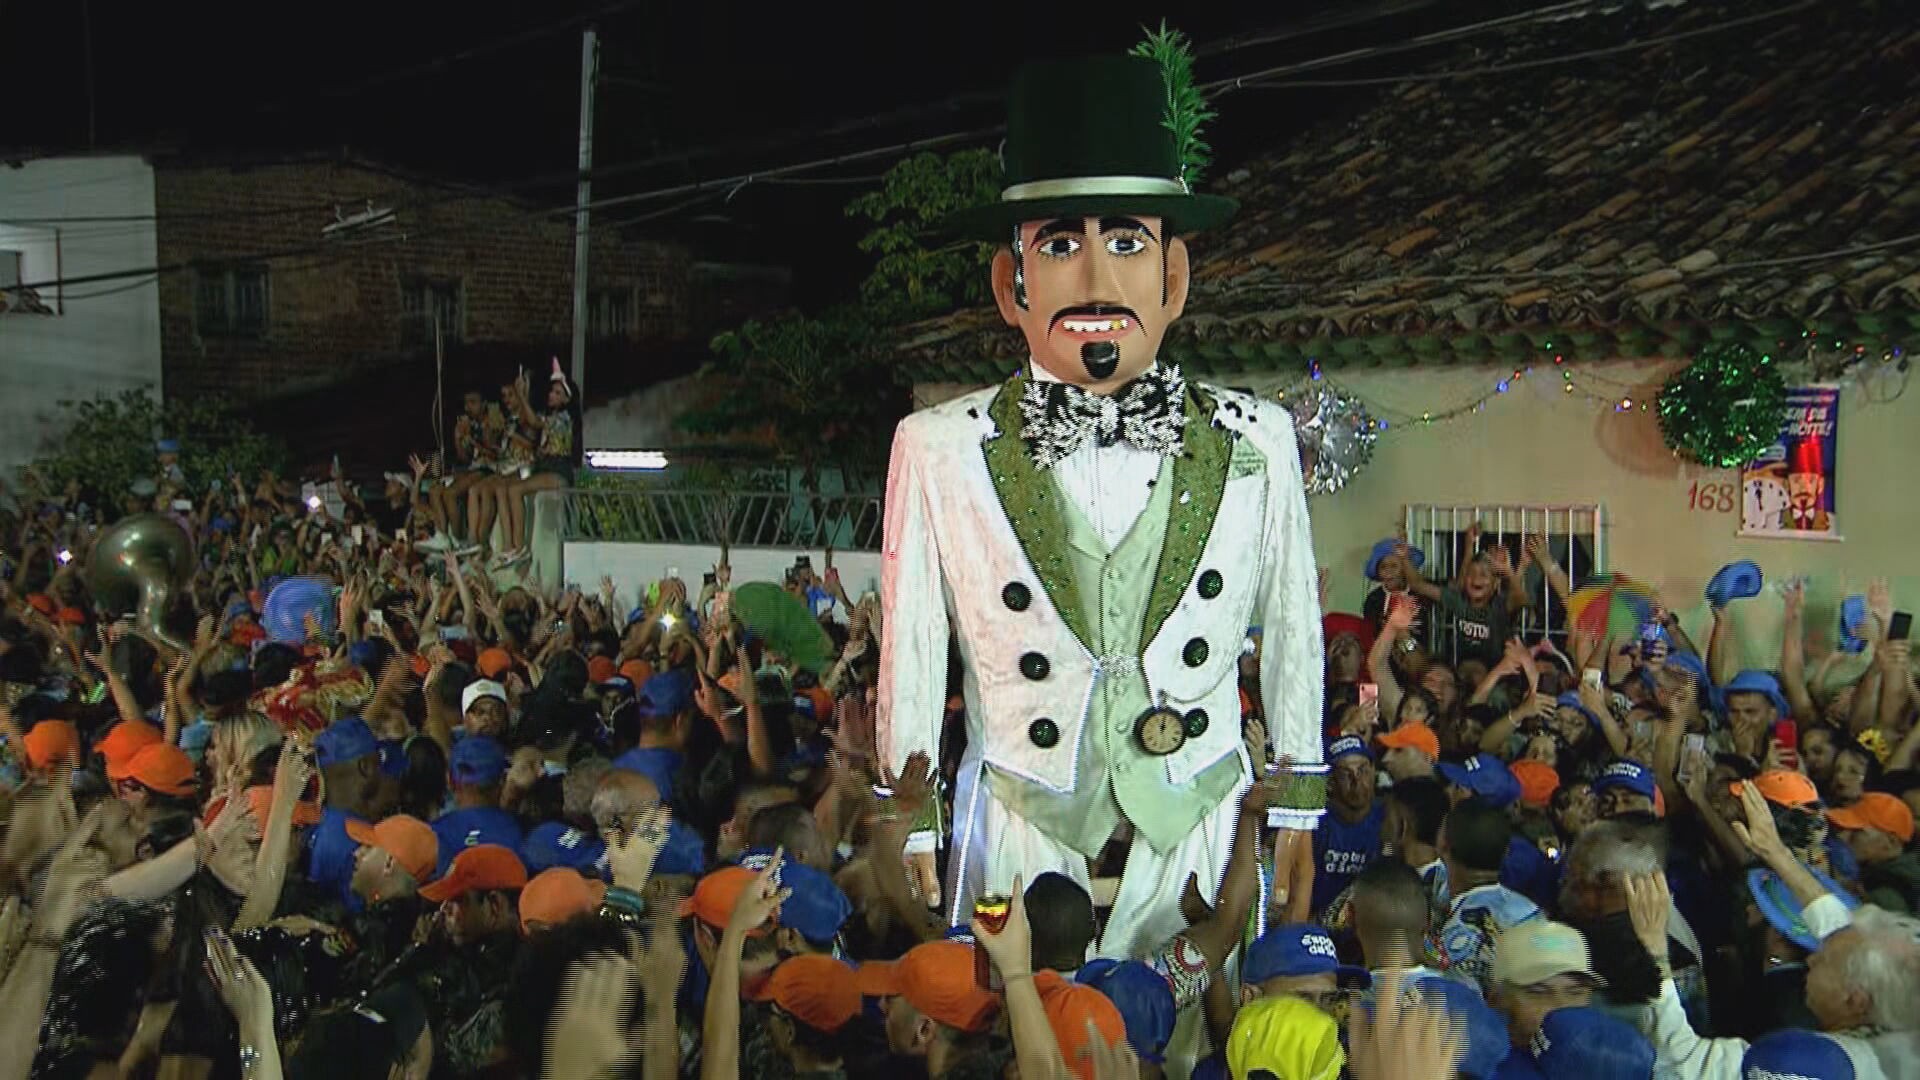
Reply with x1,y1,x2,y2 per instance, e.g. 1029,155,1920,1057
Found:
0,156,161,475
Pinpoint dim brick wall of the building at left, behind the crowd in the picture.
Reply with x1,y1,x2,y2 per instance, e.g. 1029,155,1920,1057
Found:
154,163,693,402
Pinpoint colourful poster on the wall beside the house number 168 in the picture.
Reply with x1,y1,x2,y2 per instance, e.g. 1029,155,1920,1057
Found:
1740,386,1841,540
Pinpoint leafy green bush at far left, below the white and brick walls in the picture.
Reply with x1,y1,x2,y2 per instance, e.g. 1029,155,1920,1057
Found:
31,390,286,507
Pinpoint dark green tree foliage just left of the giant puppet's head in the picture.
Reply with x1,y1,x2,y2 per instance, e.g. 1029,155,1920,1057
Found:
680,150,1000,477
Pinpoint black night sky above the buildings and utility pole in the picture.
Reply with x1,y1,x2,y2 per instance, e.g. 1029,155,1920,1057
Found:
0,0,1497,302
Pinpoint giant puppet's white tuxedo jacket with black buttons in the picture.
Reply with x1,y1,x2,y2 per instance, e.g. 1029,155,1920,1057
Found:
876,377,1325,828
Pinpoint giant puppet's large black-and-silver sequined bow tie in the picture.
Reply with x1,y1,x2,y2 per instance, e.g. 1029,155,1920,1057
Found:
1020,367,1187,469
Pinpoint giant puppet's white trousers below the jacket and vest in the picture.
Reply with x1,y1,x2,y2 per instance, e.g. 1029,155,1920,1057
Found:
947,755,1246,959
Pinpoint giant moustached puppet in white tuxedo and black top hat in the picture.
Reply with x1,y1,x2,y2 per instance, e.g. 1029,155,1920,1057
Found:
877,58,1325,957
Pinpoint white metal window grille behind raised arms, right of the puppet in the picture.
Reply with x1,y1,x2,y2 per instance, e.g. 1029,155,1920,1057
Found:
1404,503,1607,661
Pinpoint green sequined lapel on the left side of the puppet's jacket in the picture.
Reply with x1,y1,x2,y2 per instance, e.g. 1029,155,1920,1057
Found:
981,371,1098,651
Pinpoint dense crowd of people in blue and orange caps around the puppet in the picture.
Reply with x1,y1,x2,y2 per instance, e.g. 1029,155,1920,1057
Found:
0,413,1920,1080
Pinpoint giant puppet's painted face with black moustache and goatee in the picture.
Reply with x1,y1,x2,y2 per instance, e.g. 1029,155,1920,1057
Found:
993,217,1187,394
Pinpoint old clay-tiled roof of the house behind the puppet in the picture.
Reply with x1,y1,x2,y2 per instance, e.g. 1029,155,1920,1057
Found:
904,0,1920,380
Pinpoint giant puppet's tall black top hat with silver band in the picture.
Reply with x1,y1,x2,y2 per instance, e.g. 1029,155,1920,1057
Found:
943,56,1238,240
